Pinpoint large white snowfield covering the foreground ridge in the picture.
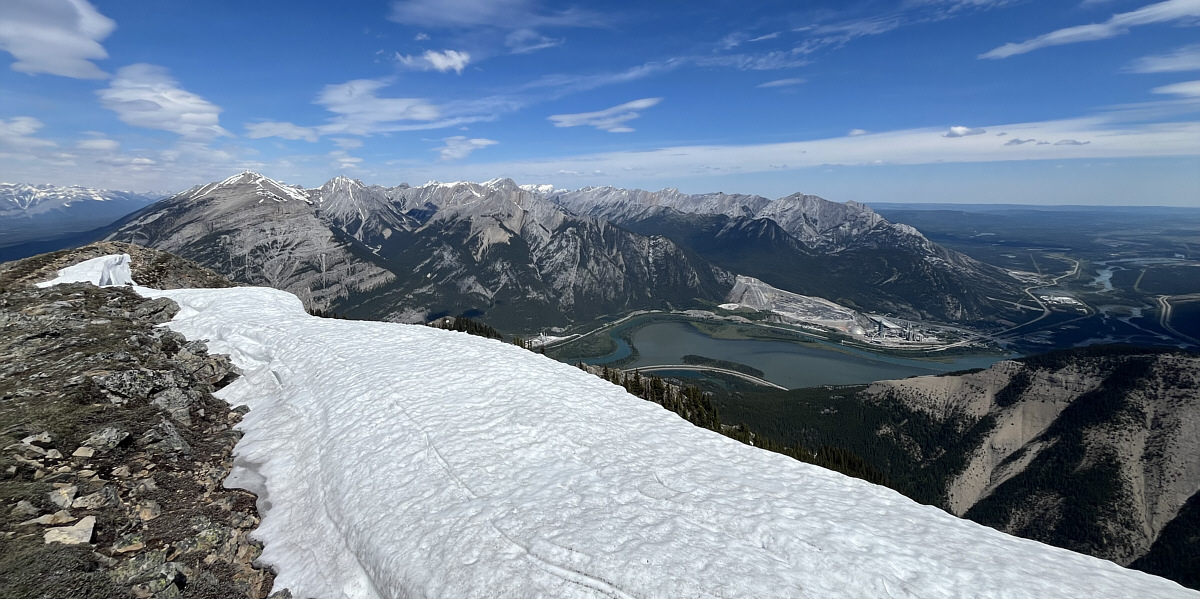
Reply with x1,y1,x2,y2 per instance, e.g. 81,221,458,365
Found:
37,258,1198,599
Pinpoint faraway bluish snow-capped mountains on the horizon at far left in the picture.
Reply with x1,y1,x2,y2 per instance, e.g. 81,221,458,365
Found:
0,182,168,245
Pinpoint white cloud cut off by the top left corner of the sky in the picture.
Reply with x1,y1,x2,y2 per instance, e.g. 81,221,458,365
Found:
0,0,116,79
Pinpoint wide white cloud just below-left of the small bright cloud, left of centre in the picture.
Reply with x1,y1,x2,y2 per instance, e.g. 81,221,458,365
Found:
317,79,454,136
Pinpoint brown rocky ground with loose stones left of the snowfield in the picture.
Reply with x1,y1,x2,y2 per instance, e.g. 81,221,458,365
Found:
0,245,284,599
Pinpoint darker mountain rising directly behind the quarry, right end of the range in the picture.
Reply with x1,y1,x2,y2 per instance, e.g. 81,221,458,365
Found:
547,187,1020,322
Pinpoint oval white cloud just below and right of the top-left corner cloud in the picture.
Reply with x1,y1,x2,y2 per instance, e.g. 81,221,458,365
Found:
96,64,230,139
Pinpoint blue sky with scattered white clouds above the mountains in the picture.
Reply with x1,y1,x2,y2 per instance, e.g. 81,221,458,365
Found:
0,0,1200,206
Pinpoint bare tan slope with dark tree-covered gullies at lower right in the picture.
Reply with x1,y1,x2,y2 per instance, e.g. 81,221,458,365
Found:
865,347,1200,577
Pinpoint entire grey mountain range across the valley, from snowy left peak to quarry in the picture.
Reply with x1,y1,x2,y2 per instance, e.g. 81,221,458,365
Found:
98,172,1020,331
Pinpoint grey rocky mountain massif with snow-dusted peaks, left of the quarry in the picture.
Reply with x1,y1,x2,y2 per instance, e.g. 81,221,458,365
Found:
109,173,733,330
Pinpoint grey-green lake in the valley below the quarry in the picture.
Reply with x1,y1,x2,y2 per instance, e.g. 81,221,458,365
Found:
588,322,1002,389
